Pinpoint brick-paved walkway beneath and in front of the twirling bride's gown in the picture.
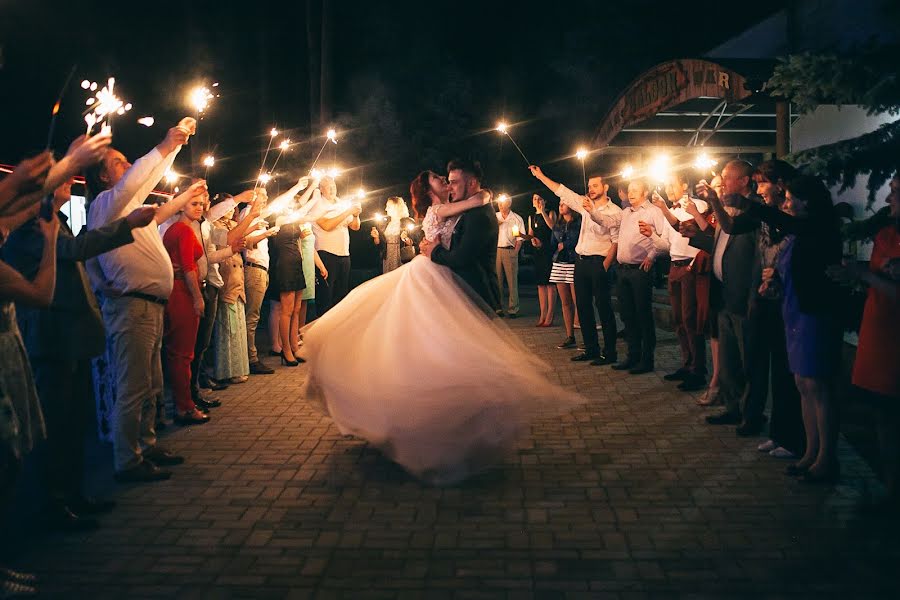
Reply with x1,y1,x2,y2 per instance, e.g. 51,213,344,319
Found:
8,298,900,598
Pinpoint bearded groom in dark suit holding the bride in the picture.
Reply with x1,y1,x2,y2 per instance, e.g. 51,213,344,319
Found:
420,160,500,311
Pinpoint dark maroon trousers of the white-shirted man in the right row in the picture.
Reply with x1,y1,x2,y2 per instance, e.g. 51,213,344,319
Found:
669,264,709,377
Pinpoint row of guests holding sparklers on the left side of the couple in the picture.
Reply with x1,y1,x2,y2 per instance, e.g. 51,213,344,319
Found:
0,118,360,597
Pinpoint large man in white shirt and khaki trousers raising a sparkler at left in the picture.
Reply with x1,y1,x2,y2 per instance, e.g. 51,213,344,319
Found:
85,117,200,482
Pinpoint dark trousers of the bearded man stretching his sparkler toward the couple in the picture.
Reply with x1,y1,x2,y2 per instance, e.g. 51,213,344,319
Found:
574,256,616,358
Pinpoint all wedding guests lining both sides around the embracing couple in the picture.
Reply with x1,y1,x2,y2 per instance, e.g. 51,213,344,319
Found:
0,118,900,594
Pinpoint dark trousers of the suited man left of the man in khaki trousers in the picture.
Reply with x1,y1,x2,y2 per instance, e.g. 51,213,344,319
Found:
31,358,94,503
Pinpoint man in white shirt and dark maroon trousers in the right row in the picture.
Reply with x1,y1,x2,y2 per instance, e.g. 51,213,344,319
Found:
653,173,709,392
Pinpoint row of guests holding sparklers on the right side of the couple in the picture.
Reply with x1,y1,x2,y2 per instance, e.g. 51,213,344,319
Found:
528,160,900,510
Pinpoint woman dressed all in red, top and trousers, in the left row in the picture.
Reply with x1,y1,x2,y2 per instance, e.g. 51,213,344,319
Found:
163,195,209,425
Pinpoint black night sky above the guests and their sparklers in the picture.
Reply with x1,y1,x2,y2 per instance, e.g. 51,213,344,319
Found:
0,0,784,262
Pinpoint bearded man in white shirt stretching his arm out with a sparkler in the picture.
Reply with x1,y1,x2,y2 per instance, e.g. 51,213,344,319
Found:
531,167,622,365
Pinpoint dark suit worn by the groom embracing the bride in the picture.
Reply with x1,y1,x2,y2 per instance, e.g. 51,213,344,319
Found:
431,205,500,310
